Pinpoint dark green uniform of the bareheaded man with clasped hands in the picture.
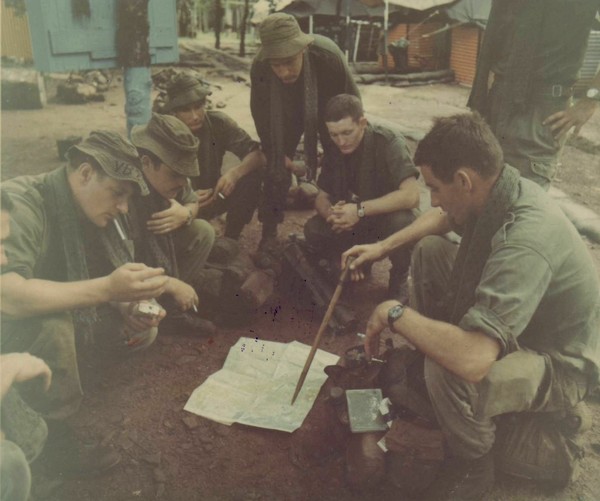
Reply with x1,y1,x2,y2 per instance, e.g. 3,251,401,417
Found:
304,124,419,293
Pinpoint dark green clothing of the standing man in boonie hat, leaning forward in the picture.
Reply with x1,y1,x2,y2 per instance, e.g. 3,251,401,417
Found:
250,33,360,232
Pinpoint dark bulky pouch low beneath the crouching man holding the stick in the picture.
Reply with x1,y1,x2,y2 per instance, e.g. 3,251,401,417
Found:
495,406,584,489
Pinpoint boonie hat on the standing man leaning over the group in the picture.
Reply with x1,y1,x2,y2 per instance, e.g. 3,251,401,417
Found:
256,12,315,60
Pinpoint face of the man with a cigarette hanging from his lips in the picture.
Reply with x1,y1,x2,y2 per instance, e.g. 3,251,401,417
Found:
75,170,134,228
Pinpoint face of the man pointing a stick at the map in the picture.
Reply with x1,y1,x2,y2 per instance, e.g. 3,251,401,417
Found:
421,165,470,227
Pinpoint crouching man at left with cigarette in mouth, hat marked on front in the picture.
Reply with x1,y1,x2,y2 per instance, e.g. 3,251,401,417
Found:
1,131,167,460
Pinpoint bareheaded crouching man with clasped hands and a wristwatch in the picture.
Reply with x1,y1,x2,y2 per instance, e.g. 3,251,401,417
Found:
304,94,419,298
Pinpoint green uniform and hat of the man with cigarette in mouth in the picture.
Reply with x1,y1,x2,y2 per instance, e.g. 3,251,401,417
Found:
1,131,156,419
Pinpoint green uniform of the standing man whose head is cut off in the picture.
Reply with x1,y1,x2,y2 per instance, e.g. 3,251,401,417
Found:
468,0,600,189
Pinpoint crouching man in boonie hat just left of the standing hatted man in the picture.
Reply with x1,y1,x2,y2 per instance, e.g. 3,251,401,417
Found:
162,73,265,240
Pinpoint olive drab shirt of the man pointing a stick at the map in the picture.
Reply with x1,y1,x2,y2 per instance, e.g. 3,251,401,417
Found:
459,179,600,388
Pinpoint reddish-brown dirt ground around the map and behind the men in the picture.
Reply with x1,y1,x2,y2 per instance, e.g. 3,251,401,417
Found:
2,38,600,501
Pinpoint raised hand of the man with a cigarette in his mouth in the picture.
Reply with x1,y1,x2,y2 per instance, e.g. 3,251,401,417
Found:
106,263,169,301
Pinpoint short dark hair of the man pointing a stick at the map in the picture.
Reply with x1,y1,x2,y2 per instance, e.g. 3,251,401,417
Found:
415,112,504,183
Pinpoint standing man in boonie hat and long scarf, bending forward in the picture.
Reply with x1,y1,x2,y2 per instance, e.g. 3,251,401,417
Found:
250,13,360,267
